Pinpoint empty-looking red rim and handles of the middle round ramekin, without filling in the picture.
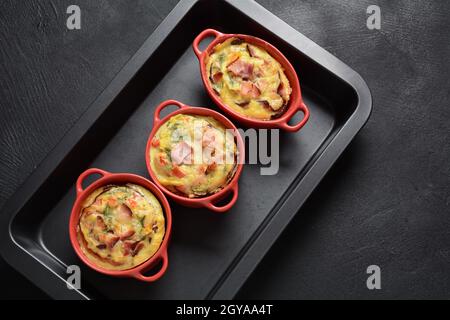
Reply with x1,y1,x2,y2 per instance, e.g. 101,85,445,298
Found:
145,100,245,212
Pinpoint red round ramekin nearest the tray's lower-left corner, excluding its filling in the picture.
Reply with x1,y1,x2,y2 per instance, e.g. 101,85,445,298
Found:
69,168,172,282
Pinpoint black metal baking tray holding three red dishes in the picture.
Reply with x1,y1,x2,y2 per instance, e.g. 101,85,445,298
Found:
0,0,372,299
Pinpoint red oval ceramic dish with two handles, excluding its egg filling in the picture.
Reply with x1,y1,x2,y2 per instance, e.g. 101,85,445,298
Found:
192,29,309,132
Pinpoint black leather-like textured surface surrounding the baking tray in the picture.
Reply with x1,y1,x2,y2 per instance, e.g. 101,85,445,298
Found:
0,0,450,298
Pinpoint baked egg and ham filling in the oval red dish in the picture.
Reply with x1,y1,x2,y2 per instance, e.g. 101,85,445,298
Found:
206,38,292,120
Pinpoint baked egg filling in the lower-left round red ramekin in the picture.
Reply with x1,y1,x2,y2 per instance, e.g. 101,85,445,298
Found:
77,184,165,270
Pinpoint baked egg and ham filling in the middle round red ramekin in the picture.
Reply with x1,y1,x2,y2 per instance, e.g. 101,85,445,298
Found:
150,114,237,198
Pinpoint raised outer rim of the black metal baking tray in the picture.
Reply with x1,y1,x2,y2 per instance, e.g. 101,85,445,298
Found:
0,0,372,299
